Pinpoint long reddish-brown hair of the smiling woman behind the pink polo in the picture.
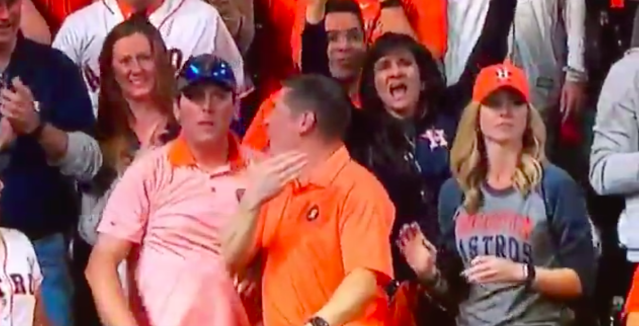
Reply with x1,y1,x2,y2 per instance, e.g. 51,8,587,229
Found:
96,13,176,168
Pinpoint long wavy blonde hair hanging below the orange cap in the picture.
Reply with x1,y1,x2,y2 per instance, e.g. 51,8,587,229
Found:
450,102,546,214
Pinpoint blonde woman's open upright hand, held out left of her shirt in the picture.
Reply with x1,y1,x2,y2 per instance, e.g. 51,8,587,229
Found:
397,222,437,280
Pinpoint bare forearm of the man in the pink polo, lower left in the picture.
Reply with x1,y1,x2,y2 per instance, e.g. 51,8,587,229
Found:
86,264,137,326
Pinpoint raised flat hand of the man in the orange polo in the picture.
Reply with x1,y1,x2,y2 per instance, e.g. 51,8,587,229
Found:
241,152,308,210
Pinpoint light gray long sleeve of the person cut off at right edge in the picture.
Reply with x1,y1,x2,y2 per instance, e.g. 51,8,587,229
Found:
590,57,639,195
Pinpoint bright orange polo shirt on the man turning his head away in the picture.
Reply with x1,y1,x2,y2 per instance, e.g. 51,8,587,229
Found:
256,146,395,326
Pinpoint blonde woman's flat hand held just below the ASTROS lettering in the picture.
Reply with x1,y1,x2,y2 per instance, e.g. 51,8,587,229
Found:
462,256,526,284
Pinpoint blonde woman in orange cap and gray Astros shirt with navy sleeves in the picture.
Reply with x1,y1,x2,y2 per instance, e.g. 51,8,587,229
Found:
398,63,596,326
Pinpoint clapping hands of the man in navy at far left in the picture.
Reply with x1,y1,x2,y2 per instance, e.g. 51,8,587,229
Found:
0,77,40,134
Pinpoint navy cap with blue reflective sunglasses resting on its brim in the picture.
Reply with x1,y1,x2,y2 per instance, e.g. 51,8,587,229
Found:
177,54,237,93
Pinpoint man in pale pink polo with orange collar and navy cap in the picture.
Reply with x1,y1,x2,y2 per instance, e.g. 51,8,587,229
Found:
86,55,254,326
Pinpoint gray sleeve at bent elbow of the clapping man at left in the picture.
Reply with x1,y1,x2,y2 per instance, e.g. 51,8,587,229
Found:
49,131,102,182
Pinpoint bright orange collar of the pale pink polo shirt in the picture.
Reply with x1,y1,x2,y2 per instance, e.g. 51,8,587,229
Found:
168,133,246,171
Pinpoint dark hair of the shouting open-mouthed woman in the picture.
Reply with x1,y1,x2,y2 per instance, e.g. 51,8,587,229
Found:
347,33,446,169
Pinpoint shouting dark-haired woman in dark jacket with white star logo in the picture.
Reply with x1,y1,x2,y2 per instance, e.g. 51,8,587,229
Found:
346,33,457,326
